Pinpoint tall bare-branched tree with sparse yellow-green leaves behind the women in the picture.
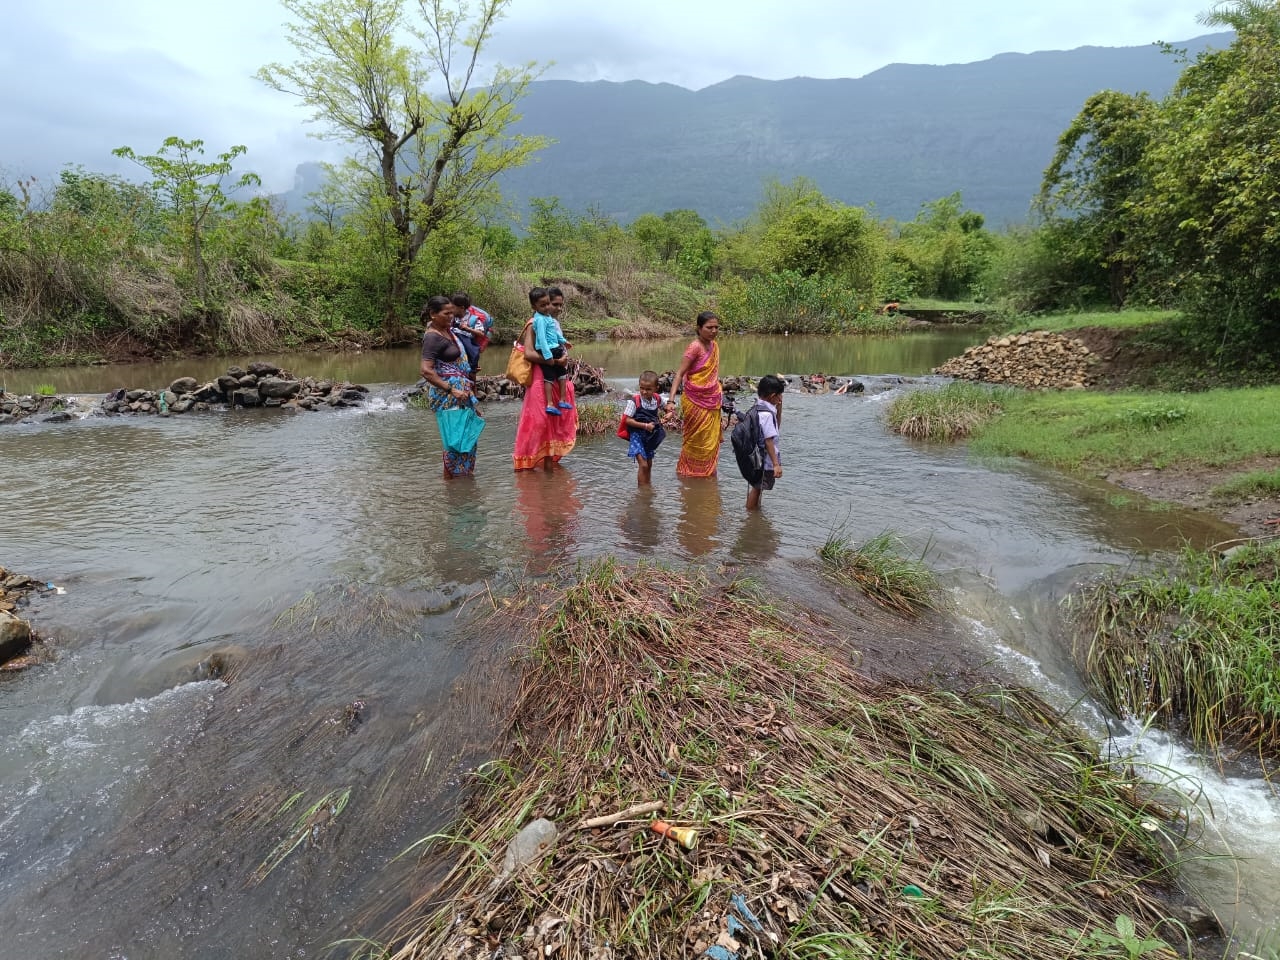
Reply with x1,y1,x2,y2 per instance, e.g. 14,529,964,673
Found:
259,0,547,337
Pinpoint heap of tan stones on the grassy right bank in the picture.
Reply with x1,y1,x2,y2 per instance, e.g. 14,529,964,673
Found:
933,330,1098,390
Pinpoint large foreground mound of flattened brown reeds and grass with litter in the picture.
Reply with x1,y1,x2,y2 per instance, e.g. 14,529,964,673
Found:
376,561,1196,960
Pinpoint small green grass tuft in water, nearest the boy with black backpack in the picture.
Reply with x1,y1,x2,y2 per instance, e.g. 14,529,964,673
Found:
818,531,938,617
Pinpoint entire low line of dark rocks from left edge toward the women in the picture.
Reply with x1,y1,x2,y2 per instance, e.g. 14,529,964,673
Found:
0,362,369,424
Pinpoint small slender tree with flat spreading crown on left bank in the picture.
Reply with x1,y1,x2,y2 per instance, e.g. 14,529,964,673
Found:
111,137,261,303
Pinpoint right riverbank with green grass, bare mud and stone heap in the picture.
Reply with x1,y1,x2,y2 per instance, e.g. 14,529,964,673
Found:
913,311,1280,536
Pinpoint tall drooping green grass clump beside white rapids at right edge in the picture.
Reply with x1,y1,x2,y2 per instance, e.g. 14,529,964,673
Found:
1078,541,1280,764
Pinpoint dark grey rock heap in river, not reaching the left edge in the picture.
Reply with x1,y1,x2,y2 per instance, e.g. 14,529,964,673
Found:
102,362,369,415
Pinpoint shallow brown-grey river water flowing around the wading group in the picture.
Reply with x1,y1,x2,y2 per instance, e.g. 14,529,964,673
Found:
0,330,1280,957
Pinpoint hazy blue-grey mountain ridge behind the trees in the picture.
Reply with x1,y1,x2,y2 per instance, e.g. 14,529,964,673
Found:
285,33,1231,227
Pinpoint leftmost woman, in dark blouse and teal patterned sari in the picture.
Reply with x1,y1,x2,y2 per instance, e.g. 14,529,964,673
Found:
421,297,484,479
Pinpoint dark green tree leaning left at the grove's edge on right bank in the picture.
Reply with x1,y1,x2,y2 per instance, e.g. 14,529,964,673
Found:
1037,90,1157,308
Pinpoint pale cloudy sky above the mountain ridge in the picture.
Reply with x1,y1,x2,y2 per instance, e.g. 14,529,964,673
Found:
0,0,1213,191
